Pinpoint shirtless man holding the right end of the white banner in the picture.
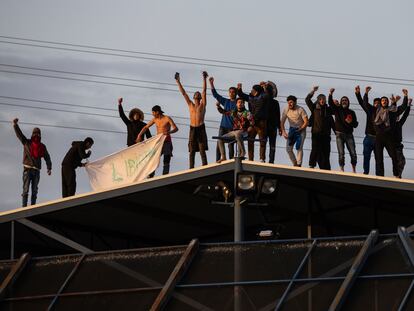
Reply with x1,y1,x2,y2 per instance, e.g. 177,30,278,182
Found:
136,105,178,175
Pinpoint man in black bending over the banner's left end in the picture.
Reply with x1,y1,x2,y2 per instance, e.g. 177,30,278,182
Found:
62,137,93,198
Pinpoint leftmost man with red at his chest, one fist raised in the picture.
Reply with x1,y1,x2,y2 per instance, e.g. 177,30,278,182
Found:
13,118,52,207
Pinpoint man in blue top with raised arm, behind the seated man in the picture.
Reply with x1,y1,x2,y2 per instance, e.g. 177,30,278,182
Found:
209,77,237,161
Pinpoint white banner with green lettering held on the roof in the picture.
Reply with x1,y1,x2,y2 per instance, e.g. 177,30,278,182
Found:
85,134,166,191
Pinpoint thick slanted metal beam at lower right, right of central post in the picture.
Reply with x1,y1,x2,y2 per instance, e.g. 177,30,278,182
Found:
328,230,378,311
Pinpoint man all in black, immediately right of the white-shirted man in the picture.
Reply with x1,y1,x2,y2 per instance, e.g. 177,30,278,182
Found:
305,86,333,170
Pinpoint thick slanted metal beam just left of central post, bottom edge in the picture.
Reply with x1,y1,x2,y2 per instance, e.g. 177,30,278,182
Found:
150,239,199,311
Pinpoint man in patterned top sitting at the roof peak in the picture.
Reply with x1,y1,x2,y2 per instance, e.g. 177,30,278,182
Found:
216,98,254,163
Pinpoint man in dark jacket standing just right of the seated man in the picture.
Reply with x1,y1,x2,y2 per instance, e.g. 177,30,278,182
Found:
237,83,273,162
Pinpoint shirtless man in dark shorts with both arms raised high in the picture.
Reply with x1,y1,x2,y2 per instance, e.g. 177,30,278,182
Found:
174,71,208,169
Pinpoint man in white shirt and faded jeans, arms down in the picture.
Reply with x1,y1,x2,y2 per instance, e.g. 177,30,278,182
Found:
279,95,309,166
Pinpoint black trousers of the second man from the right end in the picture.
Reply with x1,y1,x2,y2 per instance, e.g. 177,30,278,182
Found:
375,131,399,176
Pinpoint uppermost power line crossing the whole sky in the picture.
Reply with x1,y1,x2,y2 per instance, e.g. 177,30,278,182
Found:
0,36,414,82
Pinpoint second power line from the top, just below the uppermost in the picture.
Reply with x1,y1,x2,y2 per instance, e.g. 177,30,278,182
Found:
0,40,414,86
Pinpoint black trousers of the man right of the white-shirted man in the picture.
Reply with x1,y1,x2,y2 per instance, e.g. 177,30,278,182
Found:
309,133,331,170
